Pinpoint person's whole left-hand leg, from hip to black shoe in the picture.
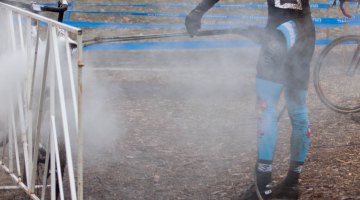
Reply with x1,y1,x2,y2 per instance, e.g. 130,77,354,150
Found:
249,17,287,199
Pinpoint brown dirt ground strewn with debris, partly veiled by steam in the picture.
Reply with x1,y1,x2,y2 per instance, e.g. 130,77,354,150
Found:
0,0,360,200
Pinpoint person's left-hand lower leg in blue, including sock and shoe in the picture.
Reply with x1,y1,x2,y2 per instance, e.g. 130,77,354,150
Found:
256,78,283,196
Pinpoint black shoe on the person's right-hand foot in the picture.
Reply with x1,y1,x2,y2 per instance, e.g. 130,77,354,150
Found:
273,180,300,200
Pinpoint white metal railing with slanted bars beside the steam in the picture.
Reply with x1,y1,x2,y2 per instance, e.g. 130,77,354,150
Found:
0,3,83,200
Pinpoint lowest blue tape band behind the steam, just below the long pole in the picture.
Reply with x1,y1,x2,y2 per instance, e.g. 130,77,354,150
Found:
84,39,331,51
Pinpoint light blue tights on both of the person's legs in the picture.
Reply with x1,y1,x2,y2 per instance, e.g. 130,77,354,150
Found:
256,78,310,162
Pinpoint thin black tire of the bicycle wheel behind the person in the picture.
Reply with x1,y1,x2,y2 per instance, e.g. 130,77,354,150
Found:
313,35,360,113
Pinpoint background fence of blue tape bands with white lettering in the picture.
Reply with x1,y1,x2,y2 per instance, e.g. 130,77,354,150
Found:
35,0,360,51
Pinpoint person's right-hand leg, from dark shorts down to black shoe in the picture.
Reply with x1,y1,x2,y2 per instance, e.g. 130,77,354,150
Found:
273,13,315,199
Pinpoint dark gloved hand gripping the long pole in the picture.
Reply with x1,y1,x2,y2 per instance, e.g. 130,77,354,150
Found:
185,8,206,37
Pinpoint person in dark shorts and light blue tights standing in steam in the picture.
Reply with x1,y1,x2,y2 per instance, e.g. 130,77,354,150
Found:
185,0,349,199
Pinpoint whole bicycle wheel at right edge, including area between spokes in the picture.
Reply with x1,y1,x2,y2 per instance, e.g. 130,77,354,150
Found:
313,35,360,113
